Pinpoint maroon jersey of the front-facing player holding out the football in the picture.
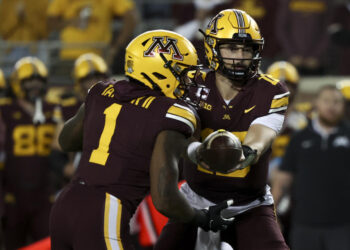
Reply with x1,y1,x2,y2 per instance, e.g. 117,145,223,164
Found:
184,71,289,204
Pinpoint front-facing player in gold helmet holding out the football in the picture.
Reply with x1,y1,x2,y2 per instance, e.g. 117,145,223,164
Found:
155,9,289,250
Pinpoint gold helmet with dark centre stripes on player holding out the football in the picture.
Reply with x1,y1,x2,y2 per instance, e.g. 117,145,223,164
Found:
200,9,264,84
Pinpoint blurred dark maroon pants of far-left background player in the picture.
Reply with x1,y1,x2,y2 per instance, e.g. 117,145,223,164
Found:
3,190,52,250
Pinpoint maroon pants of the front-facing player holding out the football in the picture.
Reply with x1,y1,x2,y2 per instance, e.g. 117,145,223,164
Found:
154,206,289,250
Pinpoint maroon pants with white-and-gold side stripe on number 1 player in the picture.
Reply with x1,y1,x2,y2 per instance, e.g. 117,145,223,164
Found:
50,184,134,250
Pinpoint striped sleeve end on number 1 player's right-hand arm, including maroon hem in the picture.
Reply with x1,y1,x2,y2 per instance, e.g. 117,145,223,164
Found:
165,103,199,137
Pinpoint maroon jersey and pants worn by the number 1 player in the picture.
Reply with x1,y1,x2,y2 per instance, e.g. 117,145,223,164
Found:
51,81,197,249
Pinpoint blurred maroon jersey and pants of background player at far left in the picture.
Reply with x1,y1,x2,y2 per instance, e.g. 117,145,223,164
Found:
0,96,56,249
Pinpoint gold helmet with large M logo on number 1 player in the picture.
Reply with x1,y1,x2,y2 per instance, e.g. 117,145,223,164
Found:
124,30,201,99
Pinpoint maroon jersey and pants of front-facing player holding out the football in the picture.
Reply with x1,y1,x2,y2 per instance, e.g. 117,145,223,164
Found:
155,71,289,250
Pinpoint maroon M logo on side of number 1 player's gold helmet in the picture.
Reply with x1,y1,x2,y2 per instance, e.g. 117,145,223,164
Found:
143,37,184,61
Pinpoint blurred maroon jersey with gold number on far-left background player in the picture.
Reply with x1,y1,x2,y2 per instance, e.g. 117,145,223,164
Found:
0,98,56,192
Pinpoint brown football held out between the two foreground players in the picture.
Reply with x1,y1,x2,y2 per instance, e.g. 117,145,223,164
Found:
198,129,242,174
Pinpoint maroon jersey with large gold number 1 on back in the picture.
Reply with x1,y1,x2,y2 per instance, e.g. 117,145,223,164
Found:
74,81,197,207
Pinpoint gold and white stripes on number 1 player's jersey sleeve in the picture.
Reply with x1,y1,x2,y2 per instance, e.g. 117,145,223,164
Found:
165,103,197,132
